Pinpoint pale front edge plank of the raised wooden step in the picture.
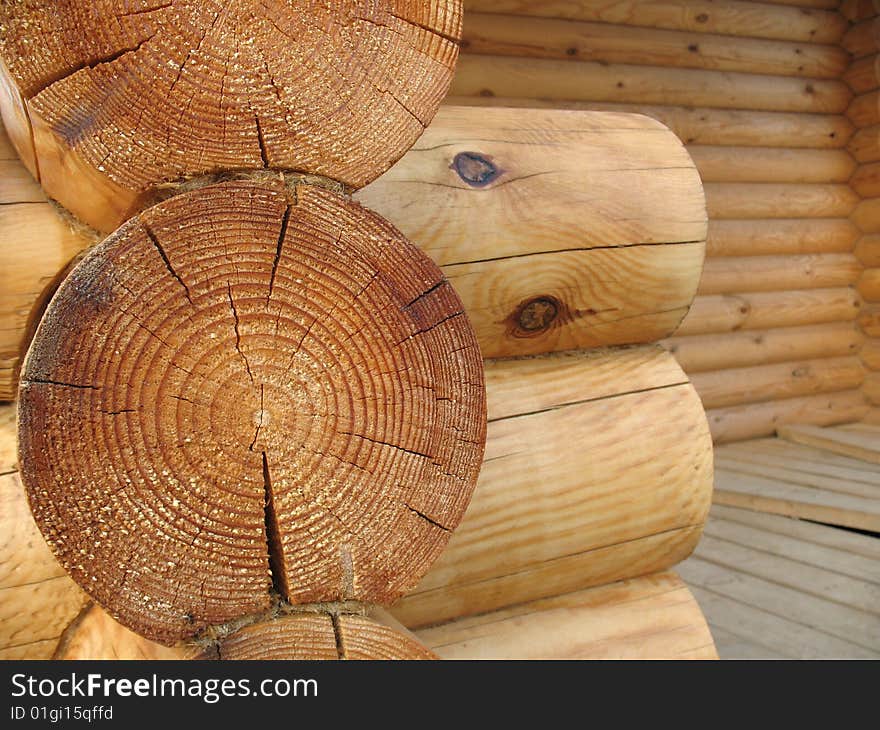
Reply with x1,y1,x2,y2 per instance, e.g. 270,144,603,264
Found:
713,469,880,531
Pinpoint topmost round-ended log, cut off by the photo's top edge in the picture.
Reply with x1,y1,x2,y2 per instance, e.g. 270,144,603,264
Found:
0,0,461,232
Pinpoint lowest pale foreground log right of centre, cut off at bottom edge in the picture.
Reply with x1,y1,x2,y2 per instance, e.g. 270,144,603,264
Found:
418,572,717,659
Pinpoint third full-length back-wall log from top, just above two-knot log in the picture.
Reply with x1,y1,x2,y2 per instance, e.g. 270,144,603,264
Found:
450,54,852,114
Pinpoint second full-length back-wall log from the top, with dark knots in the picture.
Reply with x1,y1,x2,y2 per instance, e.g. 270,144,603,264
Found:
462,13,849,78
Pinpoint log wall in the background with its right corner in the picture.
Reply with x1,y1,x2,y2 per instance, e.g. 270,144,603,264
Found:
450,0,880,442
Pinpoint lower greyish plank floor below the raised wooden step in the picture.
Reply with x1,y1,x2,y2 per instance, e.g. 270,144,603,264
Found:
679,504,880,659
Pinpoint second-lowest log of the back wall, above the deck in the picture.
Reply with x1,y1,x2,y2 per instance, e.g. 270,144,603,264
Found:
691,356,865,410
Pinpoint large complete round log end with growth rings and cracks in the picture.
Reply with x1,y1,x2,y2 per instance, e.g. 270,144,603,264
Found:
19,174,485,643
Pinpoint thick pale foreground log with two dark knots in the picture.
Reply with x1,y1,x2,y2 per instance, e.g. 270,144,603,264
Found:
356,107,706,357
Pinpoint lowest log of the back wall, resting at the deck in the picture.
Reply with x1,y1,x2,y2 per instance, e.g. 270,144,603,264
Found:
706,390,869,443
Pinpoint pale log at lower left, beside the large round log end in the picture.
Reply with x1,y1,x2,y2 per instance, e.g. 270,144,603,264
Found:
0,406,87,659
